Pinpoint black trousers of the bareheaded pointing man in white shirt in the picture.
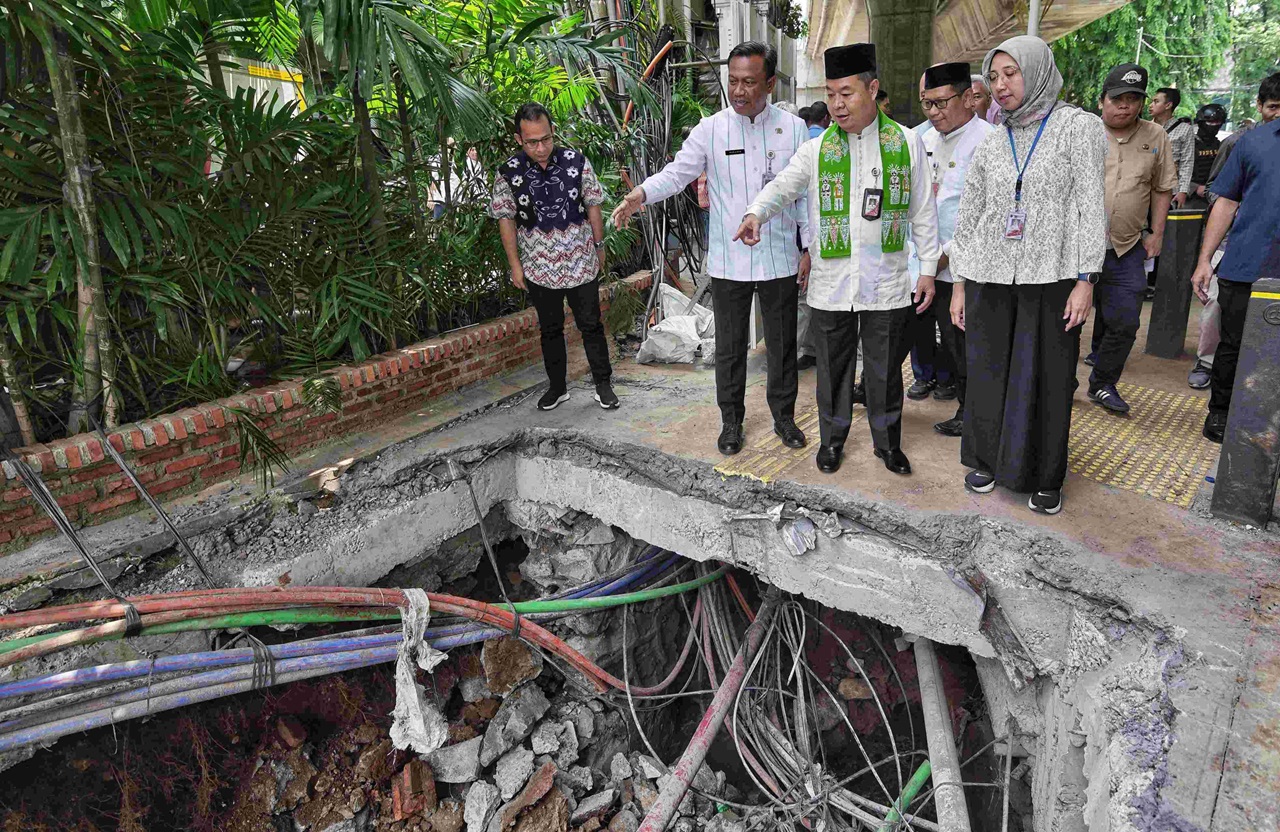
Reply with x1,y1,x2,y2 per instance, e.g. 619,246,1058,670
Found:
712,275,800,425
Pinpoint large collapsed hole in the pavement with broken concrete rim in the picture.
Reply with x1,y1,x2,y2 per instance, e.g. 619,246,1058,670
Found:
0,431,1198,832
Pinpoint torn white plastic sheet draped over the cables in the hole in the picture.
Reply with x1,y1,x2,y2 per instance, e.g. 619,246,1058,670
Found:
390,589,449,754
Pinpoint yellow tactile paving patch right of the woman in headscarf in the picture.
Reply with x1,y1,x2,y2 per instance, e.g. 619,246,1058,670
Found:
1070,383,1219,508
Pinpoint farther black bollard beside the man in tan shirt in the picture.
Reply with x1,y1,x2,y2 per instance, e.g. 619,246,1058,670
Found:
1144,207,1208,358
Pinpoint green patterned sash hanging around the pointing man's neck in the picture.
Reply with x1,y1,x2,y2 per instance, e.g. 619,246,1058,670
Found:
818,113,911,259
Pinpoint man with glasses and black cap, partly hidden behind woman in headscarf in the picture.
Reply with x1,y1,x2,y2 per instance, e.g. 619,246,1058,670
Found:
911,63,995,436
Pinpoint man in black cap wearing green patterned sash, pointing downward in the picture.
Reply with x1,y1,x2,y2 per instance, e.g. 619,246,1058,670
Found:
735,44,942,474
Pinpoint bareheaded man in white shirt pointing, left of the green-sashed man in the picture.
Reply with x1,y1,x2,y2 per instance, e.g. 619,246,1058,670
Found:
613,41,809,454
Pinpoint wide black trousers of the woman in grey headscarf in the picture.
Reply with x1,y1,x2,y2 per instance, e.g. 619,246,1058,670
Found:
960,280,1080,492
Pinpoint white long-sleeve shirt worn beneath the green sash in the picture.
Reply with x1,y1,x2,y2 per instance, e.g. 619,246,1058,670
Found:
746,116,942,312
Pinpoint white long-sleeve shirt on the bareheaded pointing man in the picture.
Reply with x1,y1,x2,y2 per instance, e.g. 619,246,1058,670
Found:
640,104,809,280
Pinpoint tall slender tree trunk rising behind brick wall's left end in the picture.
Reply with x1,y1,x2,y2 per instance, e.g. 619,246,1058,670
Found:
36,20,118,434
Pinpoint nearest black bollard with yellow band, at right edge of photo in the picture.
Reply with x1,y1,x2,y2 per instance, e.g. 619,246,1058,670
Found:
1212,278,1280,529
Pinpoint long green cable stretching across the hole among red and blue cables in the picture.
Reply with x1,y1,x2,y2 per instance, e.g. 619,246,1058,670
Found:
0,566,728,653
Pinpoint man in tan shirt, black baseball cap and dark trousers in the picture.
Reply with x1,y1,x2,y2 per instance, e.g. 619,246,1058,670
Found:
1085,64,1178,413
